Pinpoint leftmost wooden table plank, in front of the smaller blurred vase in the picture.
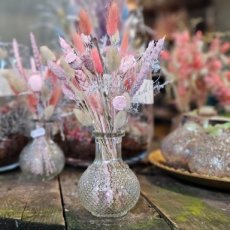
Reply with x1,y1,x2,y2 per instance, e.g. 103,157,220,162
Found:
0,172,65,230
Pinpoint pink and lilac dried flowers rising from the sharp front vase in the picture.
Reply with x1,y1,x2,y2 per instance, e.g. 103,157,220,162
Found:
49,2,164,133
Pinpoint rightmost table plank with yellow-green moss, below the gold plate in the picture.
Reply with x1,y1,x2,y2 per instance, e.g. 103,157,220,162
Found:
139,169,230,230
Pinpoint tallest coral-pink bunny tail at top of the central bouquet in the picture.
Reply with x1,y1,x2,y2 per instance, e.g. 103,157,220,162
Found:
106,2,119,36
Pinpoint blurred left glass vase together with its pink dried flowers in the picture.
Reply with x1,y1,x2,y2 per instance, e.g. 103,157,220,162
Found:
3,33,65,180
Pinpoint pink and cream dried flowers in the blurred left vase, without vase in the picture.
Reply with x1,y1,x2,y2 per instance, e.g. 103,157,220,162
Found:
6,33,62,121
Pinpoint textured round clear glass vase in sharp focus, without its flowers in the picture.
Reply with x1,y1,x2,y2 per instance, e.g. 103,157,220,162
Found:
78,133,140,217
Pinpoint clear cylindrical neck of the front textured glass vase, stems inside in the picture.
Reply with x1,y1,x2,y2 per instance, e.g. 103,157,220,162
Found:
94,133,123,162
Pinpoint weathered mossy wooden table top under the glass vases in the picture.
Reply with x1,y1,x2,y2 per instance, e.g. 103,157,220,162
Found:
0,165,230,230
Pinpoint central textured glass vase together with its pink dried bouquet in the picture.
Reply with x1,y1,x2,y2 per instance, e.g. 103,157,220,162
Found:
49,2,164,217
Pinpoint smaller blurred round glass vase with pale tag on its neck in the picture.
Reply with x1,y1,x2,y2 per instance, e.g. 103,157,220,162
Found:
19,121,65,180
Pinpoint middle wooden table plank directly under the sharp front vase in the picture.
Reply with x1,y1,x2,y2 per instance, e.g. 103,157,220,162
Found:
60,170,170,230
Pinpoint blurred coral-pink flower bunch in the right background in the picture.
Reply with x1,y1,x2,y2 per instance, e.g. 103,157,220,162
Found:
161,31,230,112
